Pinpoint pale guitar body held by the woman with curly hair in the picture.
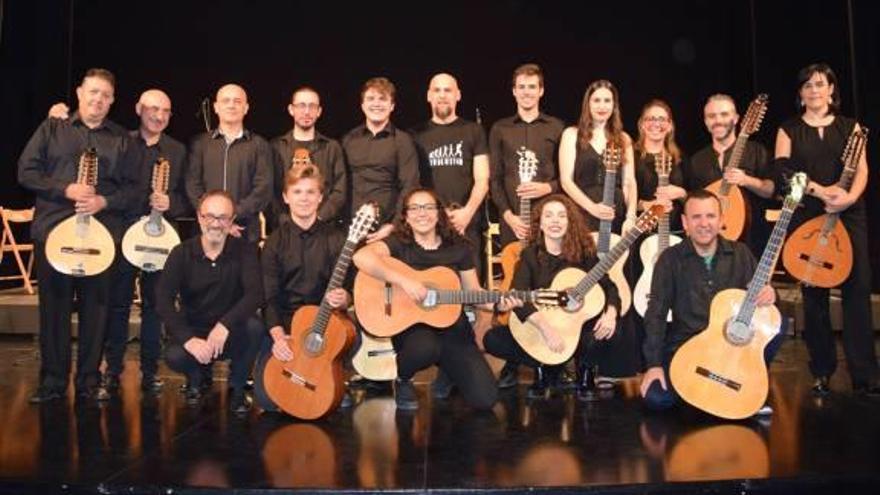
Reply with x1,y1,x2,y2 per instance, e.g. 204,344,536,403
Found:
510,268,605,364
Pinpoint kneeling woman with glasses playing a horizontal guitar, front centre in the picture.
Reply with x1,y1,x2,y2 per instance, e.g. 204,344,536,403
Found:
354,189,502,410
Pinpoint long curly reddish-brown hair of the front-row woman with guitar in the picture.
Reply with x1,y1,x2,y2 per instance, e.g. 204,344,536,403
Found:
529,193,596,264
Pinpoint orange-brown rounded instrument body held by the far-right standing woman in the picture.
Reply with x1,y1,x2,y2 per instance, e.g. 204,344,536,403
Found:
782,214,853,289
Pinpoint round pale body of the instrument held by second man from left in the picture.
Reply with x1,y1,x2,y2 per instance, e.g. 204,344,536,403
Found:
122,216,180,272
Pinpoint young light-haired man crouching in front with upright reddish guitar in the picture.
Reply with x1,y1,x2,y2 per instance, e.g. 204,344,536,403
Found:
254,165,351,410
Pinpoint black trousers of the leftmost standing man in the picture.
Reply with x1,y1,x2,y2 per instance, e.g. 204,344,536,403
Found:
34,242,110,392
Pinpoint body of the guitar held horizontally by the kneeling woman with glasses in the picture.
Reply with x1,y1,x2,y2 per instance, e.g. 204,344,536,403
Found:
354,257,461,337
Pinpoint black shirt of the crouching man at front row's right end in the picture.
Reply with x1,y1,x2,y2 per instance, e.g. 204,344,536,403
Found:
643,236,757,368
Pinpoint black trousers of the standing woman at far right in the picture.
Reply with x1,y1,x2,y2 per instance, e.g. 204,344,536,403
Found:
801,208,880,386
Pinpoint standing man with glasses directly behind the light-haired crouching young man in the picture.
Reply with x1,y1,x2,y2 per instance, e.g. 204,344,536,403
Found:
271,86,348,228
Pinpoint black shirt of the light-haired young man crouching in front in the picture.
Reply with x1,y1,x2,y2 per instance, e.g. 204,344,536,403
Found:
261,215,354,332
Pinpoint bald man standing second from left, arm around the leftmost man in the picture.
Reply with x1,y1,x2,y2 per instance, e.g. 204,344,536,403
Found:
49,89,192,393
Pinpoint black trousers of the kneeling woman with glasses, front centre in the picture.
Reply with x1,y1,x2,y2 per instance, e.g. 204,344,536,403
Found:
391,315,498,409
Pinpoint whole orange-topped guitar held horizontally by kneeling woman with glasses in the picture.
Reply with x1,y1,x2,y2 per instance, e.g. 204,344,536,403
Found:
354,257,566,337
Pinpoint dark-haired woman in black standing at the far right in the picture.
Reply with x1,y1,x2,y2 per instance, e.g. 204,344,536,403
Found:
776,64,880,396
